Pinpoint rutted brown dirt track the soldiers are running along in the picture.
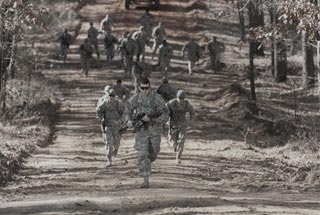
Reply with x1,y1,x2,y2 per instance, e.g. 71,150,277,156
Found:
0,0,320,215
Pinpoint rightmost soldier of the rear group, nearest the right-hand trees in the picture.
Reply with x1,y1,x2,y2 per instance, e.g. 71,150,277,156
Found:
206,36,225,72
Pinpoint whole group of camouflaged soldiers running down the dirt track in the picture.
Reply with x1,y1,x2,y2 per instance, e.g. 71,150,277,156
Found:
59,10,224,188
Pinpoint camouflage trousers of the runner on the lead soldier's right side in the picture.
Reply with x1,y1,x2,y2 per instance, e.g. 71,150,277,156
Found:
168,126,187,159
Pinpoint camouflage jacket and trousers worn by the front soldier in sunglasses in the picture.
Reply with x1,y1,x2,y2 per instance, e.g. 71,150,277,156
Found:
124,91,169,180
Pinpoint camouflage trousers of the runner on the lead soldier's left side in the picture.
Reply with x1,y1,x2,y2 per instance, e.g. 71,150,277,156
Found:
102,127,121,160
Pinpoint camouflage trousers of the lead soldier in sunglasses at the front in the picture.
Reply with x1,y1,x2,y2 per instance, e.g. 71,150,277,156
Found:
134,131,161,177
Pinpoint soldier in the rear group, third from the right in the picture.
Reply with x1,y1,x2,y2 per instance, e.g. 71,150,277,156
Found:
159,40,173,79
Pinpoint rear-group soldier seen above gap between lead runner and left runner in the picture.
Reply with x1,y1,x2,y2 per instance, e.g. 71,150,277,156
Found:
120,33,137,76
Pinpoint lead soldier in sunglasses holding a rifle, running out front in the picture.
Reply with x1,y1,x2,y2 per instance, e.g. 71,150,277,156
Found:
124,78,169,188
